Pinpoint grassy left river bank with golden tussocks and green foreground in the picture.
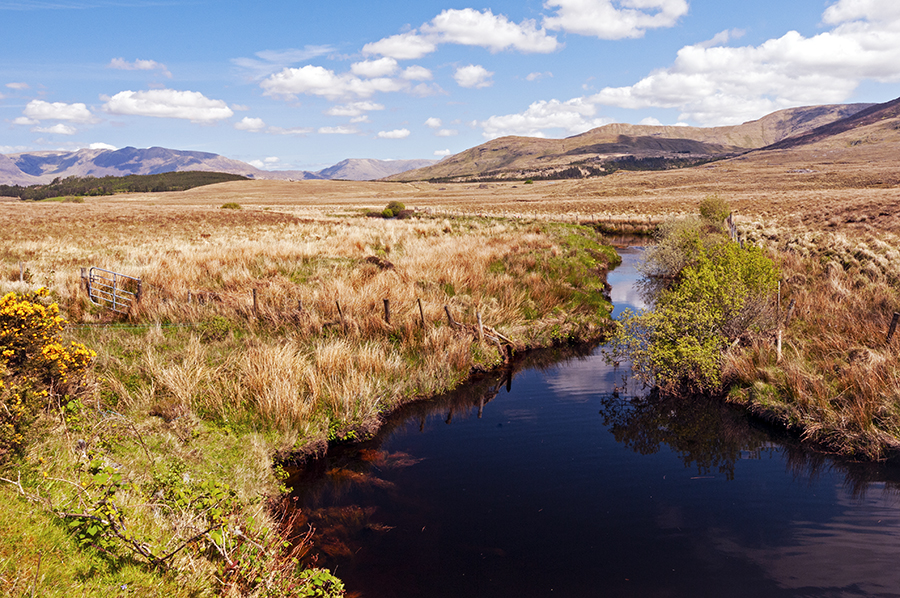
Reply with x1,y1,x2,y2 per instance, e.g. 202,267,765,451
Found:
0,199,617,596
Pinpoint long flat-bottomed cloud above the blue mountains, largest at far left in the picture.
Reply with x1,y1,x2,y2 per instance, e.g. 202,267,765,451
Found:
103,89,234,123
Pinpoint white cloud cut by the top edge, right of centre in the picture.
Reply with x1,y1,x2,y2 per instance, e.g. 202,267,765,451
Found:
543,0,688,39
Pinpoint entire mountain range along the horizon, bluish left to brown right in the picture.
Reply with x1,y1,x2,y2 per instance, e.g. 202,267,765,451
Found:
0,98,900,185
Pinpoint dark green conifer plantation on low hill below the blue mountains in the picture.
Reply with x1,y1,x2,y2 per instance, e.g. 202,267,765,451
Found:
0,171,247,201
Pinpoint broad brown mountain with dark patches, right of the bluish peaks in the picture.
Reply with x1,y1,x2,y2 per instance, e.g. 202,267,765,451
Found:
387,104,873,181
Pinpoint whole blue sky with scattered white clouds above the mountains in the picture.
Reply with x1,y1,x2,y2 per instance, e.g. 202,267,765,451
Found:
0,0,900,170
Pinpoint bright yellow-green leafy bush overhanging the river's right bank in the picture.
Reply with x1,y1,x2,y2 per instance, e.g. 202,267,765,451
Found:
614,236,779,392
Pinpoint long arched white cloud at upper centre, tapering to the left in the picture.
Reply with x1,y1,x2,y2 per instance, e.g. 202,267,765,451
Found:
363,8,560,60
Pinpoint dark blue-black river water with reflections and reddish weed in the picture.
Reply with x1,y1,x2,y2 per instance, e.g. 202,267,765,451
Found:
289,250,900,598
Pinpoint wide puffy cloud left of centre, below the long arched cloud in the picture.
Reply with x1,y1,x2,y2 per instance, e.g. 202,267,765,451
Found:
260,65,407,100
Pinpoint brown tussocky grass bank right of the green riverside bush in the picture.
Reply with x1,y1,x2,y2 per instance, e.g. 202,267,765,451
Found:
725,222,900,459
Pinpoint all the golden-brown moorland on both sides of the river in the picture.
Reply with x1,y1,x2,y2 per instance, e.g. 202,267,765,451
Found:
0,96,900,596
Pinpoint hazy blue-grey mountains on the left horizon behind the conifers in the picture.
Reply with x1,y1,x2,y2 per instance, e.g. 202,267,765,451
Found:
0,147,434,186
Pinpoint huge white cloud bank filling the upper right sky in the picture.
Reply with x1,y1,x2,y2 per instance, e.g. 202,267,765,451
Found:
589,0,900,126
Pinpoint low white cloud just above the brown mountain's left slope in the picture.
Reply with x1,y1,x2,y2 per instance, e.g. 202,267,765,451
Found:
477,98,612,139
